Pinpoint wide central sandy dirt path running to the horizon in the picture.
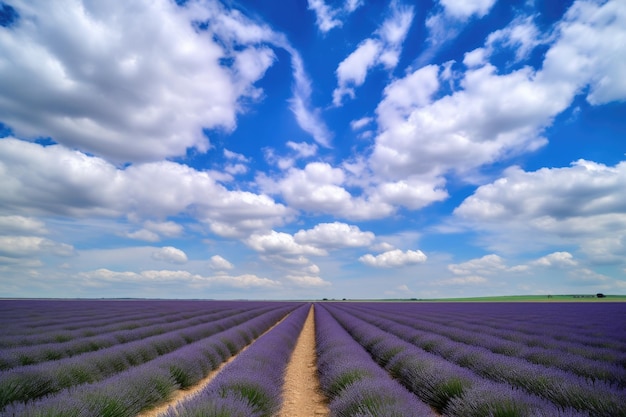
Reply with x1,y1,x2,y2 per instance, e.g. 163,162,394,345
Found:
278,306,329,417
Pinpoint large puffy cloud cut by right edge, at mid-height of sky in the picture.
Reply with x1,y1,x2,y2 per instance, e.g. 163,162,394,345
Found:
454,160,626,262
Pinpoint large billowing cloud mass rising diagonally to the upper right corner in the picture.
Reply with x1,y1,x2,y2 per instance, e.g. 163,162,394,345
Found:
370,2,626,193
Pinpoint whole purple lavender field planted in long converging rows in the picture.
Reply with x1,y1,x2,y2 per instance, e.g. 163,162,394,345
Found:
0,300,626,417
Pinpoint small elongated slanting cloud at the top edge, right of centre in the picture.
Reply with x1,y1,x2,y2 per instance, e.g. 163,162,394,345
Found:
333,2,414,106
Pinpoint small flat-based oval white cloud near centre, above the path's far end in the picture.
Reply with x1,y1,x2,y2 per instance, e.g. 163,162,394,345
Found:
294,222,375,248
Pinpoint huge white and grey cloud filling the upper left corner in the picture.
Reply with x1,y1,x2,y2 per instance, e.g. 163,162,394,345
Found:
0,0,280,161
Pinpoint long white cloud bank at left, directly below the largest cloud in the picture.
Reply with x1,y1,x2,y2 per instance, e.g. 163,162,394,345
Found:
0,139,293,237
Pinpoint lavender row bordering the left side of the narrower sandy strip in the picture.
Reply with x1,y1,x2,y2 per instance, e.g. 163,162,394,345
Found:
0,305,295,417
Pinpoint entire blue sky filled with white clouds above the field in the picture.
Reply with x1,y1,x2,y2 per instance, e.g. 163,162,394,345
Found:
0,0,626,299
